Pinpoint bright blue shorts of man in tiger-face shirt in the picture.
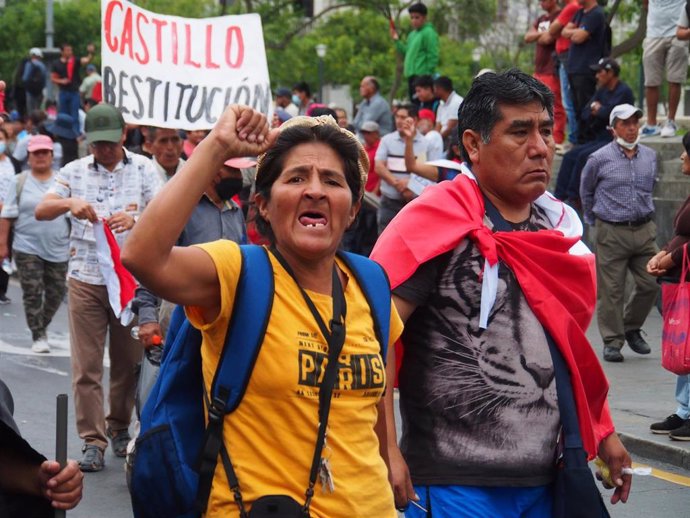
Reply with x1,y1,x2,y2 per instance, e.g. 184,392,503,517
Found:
405,485,553,518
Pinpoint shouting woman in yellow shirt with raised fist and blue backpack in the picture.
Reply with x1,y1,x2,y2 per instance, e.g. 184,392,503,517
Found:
122,105,402,518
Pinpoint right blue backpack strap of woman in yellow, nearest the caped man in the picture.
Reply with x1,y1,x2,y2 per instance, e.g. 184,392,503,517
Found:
338,252,391,363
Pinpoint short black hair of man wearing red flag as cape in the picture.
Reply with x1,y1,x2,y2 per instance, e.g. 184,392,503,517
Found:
458,68,553,165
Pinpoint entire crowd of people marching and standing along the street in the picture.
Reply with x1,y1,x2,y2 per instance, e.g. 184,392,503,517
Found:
0,0,690,518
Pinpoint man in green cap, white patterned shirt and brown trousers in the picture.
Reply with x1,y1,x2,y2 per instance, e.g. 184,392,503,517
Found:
36,103,162,471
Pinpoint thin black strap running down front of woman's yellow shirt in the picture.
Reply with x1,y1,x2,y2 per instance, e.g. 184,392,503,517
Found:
220,247,347,518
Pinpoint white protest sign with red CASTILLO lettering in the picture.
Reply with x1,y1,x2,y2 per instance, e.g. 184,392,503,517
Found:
101,0,273,130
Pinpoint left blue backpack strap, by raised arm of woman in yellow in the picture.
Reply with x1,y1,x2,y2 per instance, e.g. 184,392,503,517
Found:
210,245,275,413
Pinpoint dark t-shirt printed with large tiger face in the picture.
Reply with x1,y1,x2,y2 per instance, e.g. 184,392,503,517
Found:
394,205,560,487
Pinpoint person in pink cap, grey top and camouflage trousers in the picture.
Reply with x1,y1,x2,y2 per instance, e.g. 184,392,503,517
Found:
0,135,69,353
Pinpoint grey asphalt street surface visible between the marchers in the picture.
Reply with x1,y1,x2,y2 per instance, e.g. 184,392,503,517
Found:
0,281,690,518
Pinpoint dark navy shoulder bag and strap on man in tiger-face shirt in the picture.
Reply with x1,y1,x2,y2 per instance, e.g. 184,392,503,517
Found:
484,196,610,518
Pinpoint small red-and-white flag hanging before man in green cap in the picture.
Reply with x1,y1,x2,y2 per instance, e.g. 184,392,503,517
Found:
93,220,137,326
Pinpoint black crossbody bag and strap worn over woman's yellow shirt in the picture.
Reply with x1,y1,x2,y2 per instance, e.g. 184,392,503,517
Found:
220,247,347,518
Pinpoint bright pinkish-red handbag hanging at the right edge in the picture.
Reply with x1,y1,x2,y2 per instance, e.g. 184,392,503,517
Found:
661,243,690,375
